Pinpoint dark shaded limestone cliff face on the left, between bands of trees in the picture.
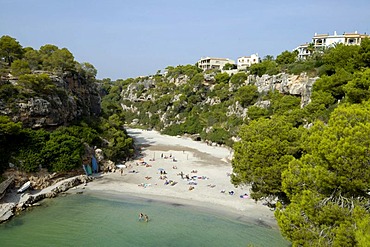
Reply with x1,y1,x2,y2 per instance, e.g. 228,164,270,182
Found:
0,73,101,128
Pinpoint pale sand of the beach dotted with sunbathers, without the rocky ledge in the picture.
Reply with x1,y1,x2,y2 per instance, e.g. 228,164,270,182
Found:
86,129,276,227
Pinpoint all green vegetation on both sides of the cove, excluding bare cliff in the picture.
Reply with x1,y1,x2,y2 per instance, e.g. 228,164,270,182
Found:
0,32,370,246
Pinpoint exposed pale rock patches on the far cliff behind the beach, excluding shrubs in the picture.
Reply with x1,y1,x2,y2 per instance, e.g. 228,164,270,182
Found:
120,73,318,129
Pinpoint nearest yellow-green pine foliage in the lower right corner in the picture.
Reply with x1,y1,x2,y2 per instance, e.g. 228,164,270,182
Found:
276,102,370,246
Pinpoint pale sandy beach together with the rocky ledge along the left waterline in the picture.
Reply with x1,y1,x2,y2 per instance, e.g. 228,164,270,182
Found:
1,129,279,230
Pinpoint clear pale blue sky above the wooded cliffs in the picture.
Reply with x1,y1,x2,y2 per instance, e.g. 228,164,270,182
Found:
0,0,370,80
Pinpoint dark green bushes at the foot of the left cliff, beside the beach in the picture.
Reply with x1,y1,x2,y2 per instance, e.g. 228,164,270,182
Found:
0,113,133,172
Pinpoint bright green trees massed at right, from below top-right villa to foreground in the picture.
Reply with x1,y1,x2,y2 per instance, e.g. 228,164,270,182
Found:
232,40,370,246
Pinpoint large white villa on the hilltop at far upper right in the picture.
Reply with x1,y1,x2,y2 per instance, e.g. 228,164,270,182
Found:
295,31,369,59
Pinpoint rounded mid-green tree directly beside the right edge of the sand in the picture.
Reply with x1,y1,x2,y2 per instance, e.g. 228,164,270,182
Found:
232,116,300,203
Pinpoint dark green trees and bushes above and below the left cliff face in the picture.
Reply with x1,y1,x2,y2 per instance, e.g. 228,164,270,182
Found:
0,36,133,174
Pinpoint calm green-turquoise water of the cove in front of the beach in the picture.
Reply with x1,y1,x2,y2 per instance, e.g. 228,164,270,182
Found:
0,194,289,247
